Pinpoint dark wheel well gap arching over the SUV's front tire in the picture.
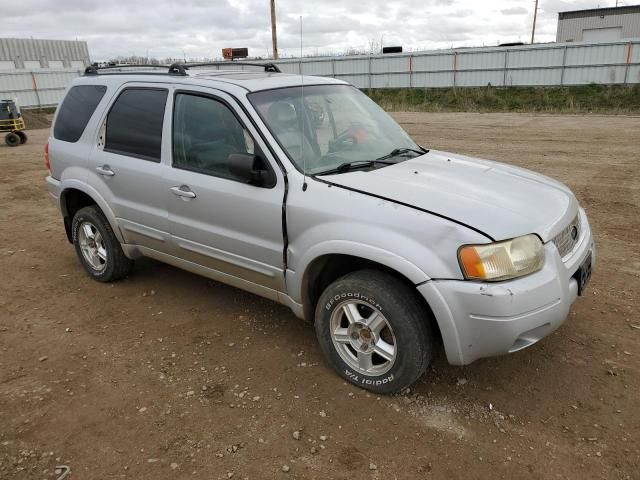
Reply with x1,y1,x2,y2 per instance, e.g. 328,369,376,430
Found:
302,254,440,335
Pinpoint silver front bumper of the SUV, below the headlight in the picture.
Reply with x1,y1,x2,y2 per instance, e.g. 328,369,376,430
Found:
418,209,595,365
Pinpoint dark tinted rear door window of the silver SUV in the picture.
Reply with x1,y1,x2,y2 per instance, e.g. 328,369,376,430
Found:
104,88,167,162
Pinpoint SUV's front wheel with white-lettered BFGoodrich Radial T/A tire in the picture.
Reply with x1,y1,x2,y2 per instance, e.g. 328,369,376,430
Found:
315,270,433,394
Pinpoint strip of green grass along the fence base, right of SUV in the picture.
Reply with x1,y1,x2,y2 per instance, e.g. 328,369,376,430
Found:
364,84,640,114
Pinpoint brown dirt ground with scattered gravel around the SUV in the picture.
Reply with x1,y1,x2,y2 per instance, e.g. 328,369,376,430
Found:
0,113,640,479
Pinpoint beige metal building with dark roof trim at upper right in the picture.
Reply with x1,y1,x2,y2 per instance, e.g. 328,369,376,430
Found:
556,5,640,42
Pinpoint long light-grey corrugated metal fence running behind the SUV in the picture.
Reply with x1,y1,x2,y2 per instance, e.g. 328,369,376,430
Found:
0,40,640,107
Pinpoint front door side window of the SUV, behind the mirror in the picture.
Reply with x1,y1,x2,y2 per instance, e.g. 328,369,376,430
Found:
173,93,255,178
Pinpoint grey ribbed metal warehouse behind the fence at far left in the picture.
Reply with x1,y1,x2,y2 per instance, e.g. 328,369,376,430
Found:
0,38,89,72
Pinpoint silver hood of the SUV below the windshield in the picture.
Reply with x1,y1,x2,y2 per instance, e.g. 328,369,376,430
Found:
322,150,578,242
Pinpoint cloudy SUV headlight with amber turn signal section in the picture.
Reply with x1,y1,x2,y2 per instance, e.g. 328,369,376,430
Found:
458,235,544,282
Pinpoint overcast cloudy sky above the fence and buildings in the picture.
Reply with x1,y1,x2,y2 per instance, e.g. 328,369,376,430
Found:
6,0,616,60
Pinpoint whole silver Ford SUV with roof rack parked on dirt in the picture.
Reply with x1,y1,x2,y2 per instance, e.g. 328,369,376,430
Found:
45,64,595,393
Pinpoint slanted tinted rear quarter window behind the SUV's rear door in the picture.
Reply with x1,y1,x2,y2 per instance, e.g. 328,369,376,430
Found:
53,85,107,142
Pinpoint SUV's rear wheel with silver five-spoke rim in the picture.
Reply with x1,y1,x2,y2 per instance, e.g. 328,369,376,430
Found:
71,205,133,282
